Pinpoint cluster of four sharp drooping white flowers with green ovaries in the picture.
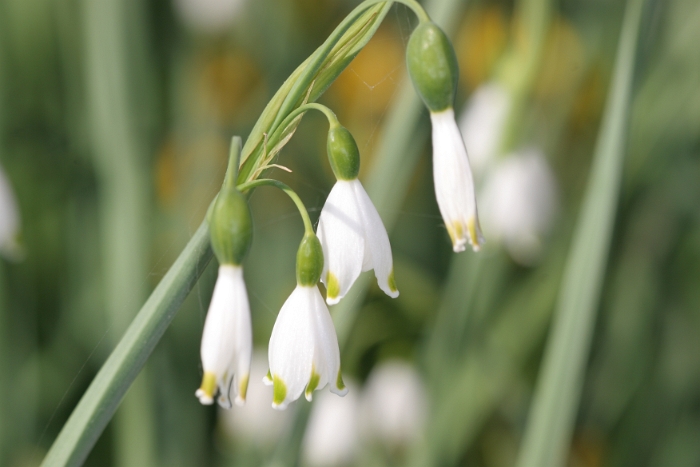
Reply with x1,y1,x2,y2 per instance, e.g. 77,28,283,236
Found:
196,5,483,409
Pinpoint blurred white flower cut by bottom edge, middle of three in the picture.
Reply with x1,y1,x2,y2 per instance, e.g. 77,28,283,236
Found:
302,384,359,467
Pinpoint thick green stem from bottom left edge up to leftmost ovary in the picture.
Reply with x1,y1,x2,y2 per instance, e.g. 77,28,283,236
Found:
42,222,212,467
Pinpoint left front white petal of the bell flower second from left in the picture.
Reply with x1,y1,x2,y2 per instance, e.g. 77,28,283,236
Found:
268,285,318,409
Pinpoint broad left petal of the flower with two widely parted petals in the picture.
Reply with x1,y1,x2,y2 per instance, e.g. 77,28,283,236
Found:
316,180,365,305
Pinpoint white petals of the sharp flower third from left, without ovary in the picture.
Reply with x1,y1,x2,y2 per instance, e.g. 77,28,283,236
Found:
316,179,399,305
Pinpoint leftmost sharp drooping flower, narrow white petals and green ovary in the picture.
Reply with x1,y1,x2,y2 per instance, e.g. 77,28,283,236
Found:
195,148,253,408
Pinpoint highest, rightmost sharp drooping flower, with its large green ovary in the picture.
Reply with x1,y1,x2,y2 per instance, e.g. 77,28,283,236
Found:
406,21,484,252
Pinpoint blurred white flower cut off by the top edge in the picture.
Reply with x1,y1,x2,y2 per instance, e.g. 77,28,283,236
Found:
174,0,246,33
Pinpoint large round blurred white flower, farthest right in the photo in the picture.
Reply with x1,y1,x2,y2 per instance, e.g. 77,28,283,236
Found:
480,149,558,265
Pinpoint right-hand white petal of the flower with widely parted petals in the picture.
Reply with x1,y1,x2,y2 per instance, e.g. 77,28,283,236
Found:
350,180,399,298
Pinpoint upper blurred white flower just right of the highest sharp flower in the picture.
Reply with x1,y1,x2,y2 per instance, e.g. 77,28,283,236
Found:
459,82,511,178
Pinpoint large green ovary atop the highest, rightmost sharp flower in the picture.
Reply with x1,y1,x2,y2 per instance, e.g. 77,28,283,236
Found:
406,21,459,112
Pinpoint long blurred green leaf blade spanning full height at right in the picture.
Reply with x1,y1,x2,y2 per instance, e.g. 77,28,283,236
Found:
517,0,644,467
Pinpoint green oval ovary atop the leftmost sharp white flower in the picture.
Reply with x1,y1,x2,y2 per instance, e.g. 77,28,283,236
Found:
209,187,253,265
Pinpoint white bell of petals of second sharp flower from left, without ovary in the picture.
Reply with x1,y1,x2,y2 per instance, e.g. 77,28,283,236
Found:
265,285,348,410
